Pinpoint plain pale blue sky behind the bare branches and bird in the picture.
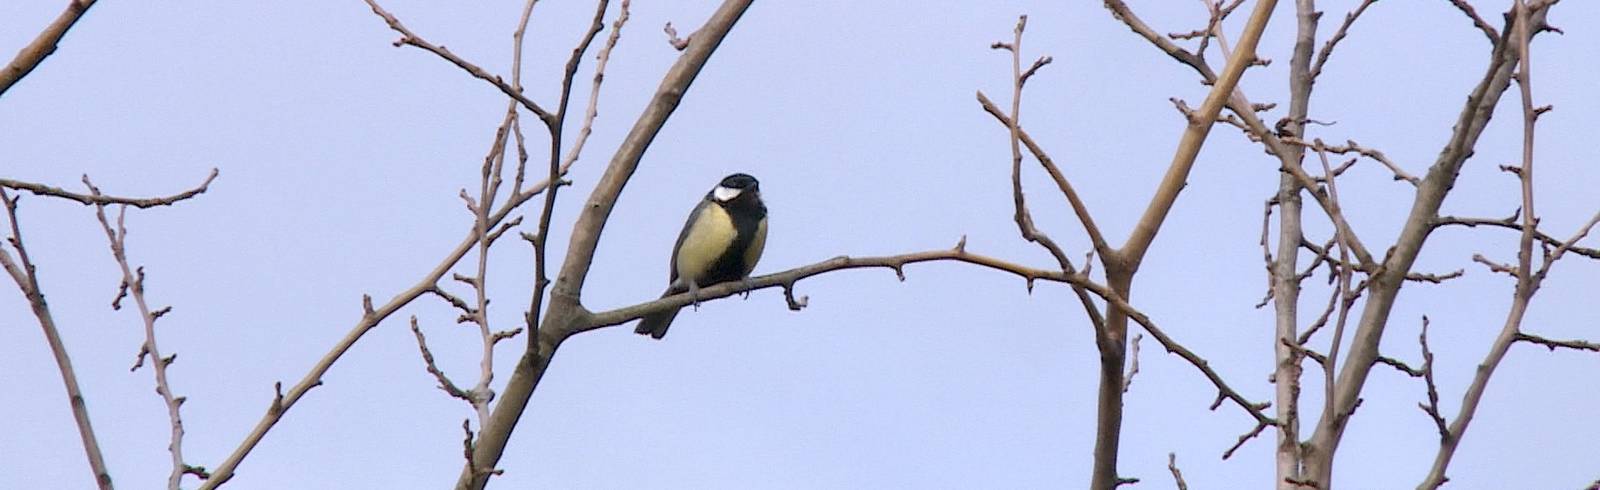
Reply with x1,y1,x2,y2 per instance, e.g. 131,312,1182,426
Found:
0,0,1600,488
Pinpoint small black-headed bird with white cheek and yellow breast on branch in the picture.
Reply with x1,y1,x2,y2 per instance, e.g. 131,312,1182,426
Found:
634,173,766,339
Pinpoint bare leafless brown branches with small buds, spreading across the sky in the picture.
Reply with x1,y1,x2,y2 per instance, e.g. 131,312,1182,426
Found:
0,0,1600,488
